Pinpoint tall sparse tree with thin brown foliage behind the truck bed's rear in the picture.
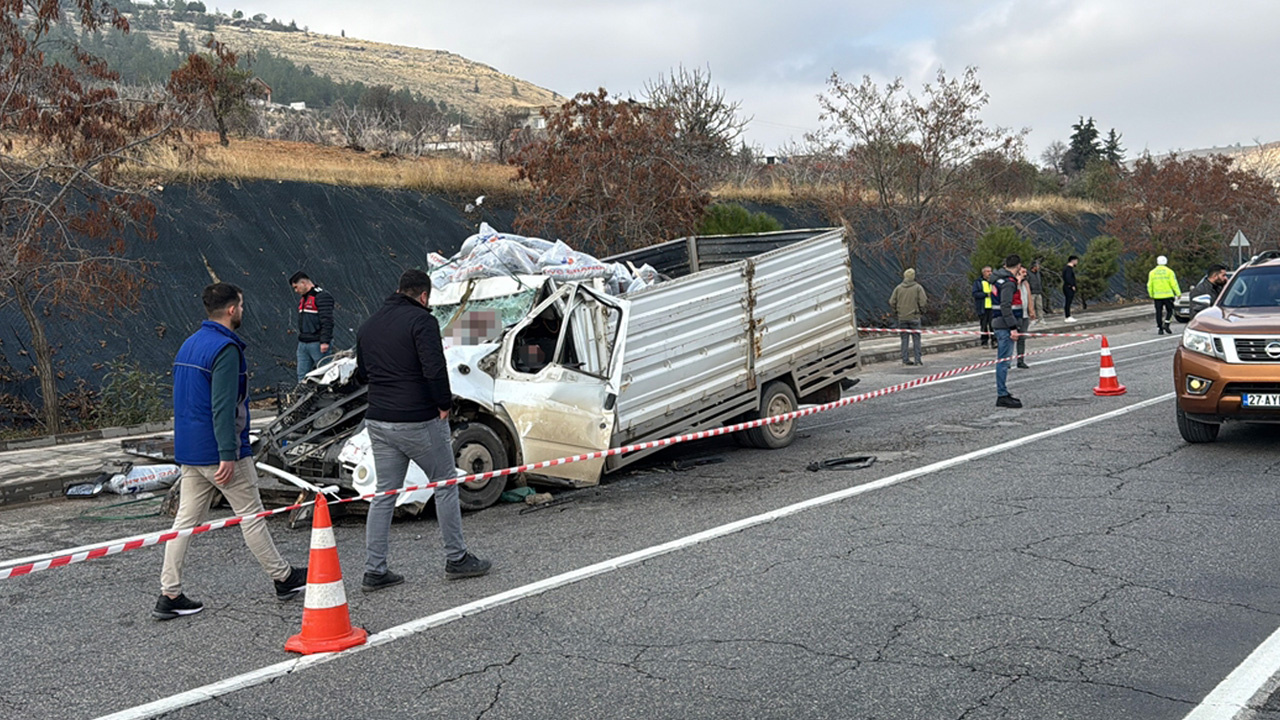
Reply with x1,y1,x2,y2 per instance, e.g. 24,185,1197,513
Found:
810,68,1027,266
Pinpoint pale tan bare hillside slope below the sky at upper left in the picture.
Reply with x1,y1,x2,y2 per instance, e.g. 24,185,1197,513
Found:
140,20,564,114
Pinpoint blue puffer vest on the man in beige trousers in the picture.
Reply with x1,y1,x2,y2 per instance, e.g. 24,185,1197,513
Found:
173,320,252,465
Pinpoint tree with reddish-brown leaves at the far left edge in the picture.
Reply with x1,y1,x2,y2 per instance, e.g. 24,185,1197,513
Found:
0,0,173,433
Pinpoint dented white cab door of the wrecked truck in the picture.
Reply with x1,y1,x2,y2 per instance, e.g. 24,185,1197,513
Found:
494,283,630,486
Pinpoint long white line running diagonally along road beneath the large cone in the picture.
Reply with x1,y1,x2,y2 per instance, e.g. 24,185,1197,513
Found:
99,392,1175,720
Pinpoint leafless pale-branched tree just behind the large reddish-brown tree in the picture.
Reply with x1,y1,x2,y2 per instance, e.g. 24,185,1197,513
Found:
644,65,751,173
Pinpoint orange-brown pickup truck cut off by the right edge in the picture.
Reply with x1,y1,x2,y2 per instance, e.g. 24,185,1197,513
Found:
1174,250,1280,442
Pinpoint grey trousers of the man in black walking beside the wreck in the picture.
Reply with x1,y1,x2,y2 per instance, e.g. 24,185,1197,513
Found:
365,419,467,575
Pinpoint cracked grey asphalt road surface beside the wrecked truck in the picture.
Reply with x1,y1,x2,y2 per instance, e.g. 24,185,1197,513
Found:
0,323,1280,720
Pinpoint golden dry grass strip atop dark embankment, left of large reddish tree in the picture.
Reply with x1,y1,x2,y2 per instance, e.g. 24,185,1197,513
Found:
131,133,524,196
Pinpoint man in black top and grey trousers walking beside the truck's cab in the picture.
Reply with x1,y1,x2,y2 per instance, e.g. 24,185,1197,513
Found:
356,270,490,592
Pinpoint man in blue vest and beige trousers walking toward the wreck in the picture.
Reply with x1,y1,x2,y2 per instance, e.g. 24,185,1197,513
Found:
151,283,307,620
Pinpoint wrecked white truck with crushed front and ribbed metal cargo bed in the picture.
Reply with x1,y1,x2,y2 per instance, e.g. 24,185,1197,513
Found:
259,229,859,510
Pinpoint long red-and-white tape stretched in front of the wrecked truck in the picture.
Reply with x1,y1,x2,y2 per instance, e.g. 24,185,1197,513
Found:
0,331,1100,580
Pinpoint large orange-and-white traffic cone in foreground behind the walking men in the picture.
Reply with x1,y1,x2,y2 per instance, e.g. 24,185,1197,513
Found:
284,495,369,655
